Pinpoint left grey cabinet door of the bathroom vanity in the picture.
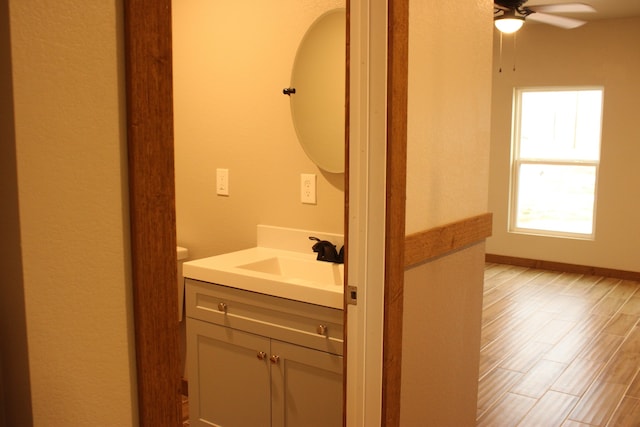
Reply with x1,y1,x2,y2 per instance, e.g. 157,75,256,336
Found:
187,318,271,427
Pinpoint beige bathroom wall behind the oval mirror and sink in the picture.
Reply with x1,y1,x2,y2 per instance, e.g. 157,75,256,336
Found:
173,0,345,258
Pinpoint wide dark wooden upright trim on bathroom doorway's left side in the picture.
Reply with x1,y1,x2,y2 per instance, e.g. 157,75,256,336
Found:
124,0,181,427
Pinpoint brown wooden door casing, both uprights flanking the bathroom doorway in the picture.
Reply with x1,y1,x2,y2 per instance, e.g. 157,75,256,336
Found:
124,0,409,427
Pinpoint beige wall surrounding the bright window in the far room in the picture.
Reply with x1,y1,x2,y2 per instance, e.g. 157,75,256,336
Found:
487,18,640,271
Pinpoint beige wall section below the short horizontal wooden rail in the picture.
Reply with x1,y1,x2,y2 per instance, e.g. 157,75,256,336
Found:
400,244,484,427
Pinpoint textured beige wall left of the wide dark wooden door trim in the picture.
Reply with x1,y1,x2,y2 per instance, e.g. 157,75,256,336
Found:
0,0,137,426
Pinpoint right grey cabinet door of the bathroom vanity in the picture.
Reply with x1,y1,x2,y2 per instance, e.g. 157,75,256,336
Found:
271,340,343,427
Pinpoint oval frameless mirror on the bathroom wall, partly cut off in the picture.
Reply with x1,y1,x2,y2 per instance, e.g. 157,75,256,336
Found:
285,9,346,173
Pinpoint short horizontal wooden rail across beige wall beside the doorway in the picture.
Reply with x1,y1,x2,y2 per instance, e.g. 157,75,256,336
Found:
404,213,493,267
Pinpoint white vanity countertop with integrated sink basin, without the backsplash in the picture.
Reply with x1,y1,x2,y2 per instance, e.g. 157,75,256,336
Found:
182,247,344,309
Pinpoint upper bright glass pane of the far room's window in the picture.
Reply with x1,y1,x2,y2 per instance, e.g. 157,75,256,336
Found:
520,90,602,160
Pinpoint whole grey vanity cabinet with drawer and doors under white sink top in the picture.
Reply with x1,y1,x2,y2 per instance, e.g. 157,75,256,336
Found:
186,279,343,427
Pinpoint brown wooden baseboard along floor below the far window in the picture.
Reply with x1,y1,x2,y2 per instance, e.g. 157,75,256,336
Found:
485,254,640,282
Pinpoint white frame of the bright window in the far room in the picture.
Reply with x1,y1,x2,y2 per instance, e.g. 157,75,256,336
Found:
508,86,604,240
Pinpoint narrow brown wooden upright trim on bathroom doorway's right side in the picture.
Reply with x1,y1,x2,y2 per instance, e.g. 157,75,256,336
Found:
381,0,409,427
